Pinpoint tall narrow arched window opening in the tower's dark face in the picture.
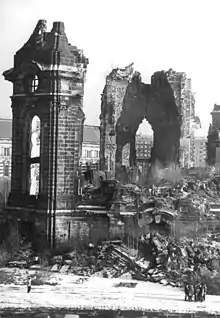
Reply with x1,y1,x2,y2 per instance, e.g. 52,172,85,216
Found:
29,116,41,196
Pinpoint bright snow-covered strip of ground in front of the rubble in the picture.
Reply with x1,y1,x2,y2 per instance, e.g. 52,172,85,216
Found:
0,274,220,314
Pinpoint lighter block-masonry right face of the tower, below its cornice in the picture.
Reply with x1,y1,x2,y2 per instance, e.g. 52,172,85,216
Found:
57,99,84,210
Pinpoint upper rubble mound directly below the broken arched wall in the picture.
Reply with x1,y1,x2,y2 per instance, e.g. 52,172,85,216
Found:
117,171,220,221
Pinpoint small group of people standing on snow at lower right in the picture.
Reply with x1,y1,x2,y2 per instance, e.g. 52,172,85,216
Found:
185,283,207,301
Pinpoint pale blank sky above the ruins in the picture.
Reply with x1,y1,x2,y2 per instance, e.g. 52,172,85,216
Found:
0,0,220,135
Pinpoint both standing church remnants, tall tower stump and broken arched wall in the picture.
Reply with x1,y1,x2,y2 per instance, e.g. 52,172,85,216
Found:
3,20,198,243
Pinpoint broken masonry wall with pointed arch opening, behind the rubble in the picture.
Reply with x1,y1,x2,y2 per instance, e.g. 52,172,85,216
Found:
100,64,196,172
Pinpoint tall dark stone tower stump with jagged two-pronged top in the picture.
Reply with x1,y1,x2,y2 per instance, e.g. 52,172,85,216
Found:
3,20,88,242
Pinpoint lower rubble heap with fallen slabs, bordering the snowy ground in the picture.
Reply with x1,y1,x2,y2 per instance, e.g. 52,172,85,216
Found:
3,233,220,294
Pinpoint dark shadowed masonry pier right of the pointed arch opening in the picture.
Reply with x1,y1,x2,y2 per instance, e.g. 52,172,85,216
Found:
146,70,182,166
